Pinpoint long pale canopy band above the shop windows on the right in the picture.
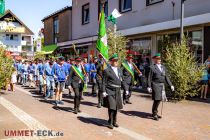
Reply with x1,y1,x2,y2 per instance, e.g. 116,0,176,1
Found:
119,13,210,36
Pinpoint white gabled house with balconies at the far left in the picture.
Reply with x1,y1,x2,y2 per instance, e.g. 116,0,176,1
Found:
0,10,34,58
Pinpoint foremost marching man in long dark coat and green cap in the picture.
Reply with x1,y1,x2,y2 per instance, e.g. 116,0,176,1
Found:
102,54,123,129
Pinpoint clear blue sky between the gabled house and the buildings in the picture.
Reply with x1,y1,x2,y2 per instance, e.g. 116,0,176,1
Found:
5,0,71,36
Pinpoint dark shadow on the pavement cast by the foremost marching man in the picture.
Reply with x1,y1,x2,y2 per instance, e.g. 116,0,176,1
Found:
77,116,108,127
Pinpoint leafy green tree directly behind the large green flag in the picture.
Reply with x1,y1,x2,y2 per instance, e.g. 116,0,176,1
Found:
107,25,128,64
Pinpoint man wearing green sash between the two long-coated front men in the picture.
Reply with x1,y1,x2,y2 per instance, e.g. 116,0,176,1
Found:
122,54,142,105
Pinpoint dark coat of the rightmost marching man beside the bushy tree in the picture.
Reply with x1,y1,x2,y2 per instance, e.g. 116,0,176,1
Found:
148,64,172,100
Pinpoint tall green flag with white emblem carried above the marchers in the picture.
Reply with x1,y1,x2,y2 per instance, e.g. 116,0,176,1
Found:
96,9,109,60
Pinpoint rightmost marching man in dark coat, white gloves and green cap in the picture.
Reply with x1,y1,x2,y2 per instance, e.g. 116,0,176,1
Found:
147,53,174,121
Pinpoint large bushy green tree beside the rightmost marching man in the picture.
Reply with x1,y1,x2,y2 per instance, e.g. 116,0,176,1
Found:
162,39,204,100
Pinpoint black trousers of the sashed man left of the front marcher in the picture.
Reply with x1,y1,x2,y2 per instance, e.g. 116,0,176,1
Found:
73,84,83,110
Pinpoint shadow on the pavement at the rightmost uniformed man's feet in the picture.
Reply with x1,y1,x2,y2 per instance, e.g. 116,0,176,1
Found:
120,110,152,119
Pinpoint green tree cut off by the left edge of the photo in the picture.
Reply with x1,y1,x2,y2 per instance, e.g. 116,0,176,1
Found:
0,46,14,89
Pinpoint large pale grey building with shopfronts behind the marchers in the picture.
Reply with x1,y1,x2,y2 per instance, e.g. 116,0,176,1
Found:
58,0,210,62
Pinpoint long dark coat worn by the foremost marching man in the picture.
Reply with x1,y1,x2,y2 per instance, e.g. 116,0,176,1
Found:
102,66,123,110
